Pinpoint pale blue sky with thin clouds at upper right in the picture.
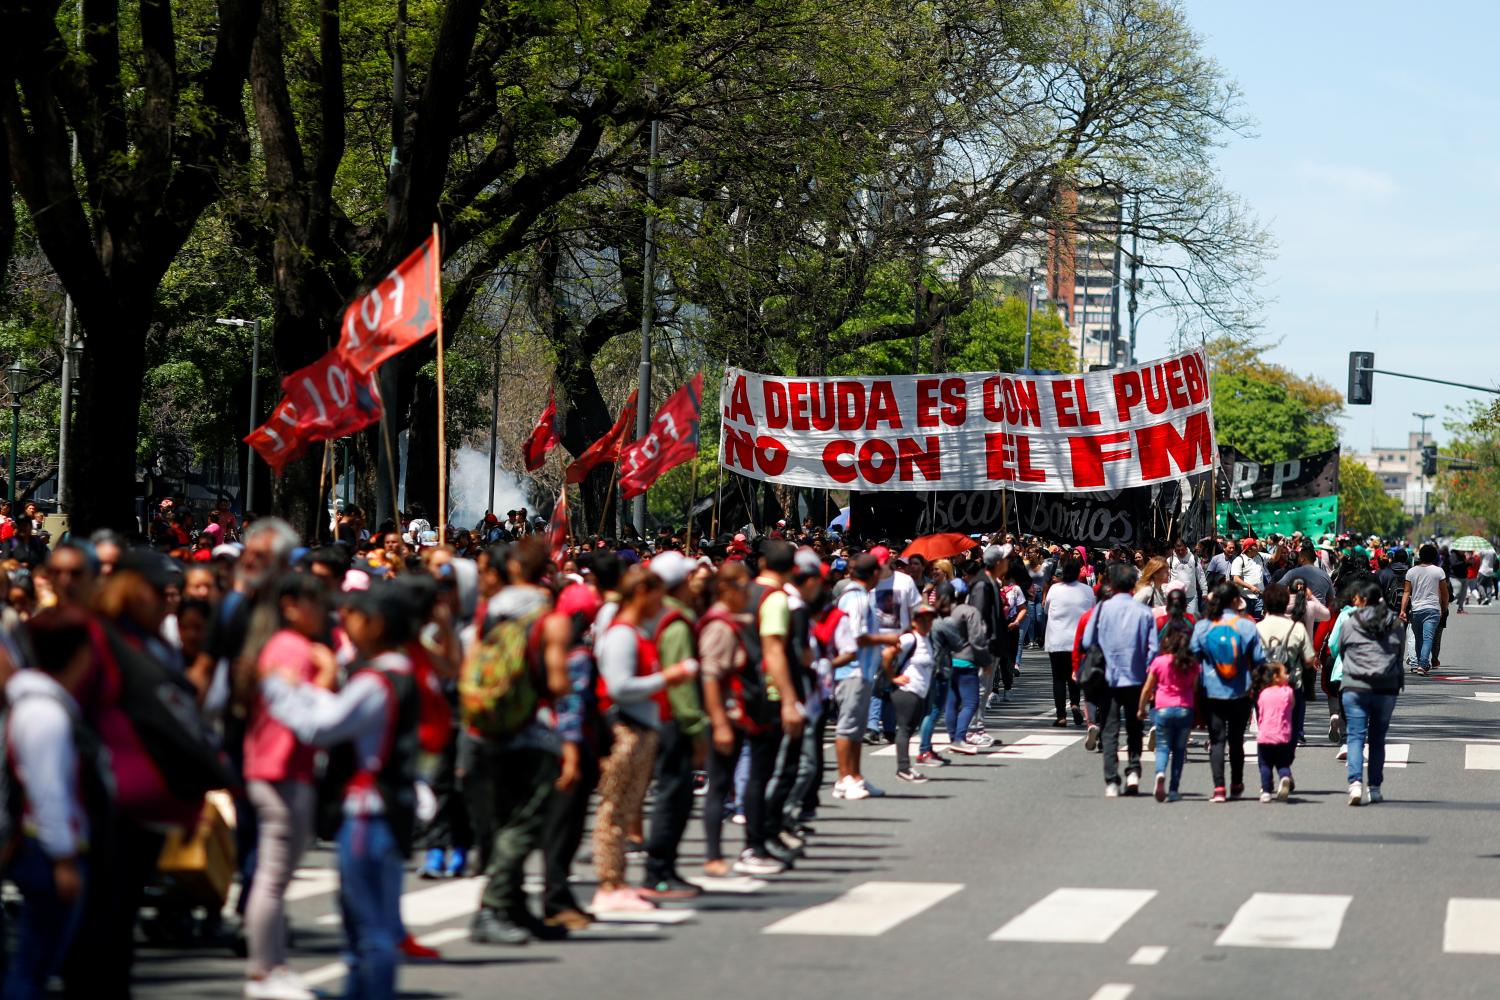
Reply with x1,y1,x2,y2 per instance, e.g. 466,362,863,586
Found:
1137,0,1500,450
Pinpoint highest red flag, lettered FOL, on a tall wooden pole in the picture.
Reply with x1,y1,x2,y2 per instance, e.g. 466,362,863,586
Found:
338,237,443,375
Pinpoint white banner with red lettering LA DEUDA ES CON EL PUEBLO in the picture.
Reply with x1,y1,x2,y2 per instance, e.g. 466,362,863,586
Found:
719,351,1217,493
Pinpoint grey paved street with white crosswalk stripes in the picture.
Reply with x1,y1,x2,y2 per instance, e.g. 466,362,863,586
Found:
140,609,1500,1000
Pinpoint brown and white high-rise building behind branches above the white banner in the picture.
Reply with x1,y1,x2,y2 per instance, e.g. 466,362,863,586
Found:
1047,190,1130,372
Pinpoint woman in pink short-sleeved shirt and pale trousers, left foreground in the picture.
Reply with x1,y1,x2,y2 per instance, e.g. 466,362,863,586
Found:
236,573,338,1000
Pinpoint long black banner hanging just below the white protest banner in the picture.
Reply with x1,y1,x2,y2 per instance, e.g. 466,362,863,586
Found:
849,475,1212,549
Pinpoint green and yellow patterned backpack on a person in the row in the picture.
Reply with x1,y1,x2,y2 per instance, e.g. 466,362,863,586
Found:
459,604,548,739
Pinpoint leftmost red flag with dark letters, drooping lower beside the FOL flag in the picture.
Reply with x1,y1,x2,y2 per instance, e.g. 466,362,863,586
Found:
245,351,381,472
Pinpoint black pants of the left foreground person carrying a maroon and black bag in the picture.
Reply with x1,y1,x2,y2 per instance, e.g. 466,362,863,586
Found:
63,819,164,1000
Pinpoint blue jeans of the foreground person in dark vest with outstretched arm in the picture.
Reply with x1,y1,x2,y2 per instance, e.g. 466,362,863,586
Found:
339,816,407,1000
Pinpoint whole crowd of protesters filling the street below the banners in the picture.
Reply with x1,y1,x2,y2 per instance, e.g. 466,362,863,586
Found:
0,488,1494,1000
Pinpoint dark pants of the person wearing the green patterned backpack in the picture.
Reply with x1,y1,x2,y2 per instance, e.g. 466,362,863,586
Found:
459,736,558,916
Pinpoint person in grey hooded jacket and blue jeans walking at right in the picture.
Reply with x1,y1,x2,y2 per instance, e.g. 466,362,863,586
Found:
1329,580,1406,805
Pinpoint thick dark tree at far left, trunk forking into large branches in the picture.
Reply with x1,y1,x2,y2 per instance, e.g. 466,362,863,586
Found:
0,0,261,528
